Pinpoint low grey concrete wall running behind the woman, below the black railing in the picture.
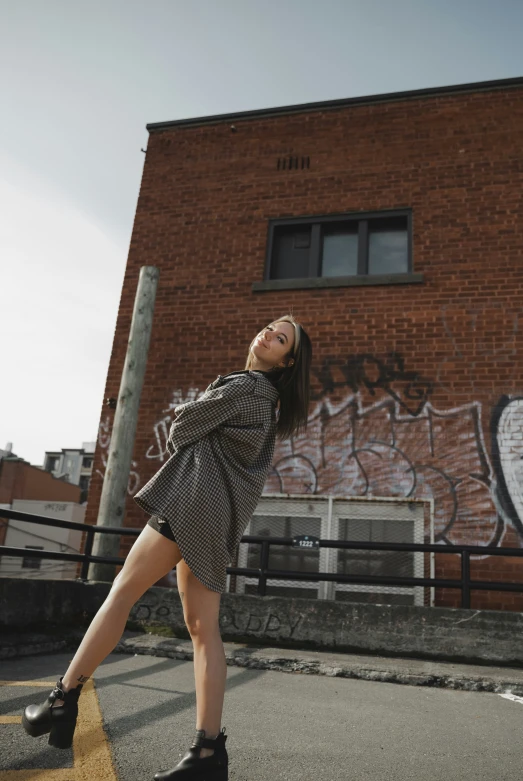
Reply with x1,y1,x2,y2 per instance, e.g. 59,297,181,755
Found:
0,578,523,666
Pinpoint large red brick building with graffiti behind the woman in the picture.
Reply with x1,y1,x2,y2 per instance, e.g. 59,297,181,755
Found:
87,78,523,610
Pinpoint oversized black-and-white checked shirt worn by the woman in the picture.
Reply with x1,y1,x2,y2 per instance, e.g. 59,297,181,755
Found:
134,371,278,592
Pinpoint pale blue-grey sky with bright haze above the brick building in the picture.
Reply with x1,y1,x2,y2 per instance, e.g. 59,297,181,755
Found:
0,0,523,464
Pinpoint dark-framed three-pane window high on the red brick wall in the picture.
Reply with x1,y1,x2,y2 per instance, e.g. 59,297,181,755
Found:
266,212,412,279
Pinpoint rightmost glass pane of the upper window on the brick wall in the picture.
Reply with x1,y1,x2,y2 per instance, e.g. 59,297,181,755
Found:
369,219,409,274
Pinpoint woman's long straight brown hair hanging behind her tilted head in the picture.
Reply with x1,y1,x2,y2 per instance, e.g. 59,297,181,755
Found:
245,315,312,439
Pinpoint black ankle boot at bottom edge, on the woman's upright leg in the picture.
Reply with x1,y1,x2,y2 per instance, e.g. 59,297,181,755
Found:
154,727,229,781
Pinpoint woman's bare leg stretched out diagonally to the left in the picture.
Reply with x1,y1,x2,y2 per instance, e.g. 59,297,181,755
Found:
56,526,182,692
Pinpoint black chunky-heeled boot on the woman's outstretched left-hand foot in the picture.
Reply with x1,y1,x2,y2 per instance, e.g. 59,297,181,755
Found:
22,678,82,748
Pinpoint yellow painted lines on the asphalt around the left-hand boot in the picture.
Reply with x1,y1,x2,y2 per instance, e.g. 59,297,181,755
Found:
0,680,118,781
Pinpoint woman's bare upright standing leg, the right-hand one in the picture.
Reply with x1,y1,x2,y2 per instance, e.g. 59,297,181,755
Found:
176,559,227,757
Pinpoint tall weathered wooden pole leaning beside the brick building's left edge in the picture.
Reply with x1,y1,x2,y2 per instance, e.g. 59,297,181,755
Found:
89,266,159,581
